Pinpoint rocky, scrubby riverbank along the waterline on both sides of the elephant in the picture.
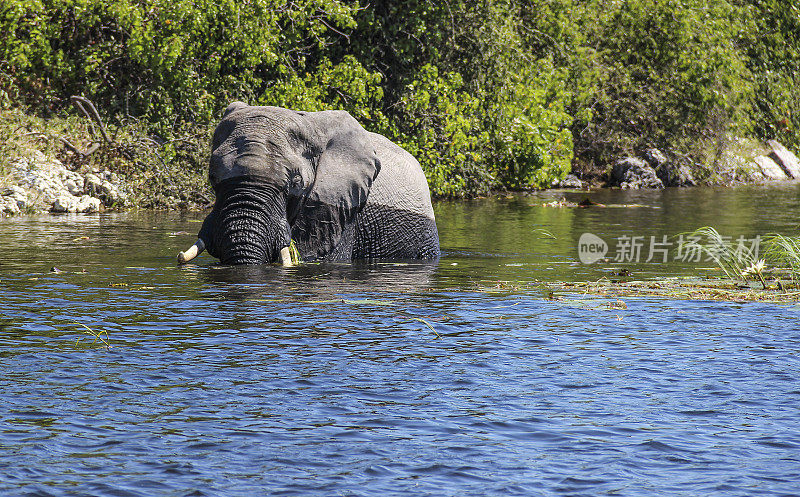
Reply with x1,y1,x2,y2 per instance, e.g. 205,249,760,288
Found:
0,106,800,216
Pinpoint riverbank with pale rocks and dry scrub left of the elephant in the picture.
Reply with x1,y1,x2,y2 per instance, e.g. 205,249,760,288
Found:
0,109,214,216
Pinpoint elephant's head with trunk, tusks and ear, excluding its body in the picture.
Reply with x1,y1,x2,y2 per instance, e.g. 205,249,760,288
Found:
178,102,380,264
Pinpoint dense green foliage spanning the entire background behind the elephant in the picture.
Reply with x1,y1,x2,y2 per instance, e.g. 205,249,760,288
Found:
0,0,800,196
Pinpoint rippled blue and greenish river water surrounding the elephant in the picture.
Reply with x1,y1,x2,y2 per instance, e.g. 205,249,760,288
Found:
0,185,800,496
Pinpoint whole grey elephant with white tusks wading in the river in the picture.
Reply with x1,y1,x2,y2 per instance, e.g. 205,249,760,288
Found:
178,102,440,266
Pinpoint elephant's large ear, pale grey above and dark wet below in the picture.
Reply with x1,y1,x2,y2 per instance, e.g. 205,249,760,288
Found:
293,124,380,259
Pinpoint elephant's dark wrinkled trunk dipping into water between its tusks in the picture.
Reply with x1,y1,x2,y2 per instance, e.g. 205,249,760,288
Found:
214,178,291,264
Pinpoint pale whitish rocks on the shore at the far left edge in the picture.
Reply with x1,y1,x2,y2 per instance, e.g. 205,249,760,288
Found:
0,150,127,216
